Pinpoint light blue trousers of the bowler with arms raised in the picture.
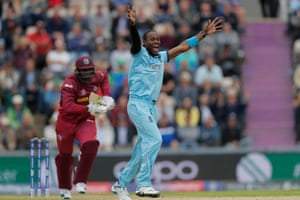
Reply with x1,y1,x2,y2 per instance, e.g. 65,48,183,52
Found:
119,99,162,187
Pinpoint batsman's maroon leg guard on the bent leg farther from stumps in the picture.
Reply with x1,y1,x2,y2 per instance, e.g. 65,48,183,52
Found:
73,140,99,184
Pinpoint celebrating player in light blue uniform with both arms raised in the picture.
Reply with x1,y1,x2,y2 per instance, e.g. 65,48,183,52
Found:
112,7,223,200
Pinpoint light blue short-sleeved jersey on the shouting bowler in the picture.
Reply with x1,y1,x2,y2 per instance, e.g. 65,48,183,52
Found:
128,47,168,101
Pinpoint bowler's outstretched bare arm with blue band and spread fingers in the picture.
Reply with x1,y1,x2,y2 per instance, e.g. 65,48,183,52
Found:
168,17,223,60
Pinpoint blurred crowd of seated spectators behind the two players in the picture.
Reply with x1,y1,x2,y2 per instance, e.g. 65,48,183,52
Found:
0,0,248,151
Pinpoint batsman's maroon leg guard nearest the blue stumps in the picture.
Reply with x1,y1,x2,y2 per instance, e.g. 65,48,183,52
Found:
55,154,74,190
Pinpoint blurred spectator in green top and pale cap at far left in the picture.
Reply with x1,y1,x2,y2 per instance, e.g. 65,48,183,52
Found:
7,94,32,130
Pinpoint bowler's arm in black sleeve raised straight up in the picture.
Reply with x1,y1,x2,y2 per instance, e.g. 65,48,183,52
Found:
127,6,141,54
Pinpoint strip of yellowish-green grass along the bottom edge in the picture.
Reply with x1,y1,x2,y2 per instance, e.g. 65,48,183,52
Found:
0,190,300,200
